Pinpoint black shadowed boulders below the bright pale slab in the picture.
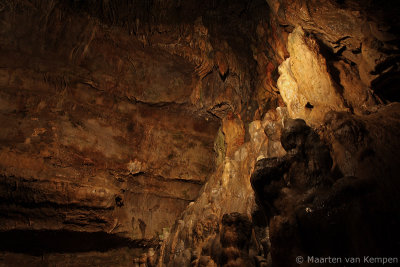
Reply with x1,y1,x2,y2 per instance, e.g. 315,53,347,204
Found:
251,104,400,266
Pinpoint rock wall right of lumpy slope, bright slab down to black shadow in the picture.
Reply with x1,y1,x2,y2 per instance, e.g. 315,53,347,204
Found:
251,1,400,266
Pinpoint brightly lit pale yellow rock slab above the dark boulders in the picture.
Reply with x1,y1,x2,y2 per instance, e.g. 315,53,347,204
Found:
277,27,345,123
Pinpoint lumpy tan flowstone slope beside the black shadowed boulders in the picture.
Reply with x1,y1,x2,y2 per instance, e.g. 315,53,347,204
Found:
161,108,286,266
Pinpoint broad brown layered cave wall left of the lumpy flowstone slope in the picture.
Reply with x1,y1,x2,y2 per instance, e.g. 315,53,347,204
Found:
0,0,272,266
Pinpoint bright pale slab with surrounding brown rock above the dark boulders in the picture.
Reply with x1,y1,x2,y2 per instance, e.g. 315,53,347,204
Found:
269,0,399,125
